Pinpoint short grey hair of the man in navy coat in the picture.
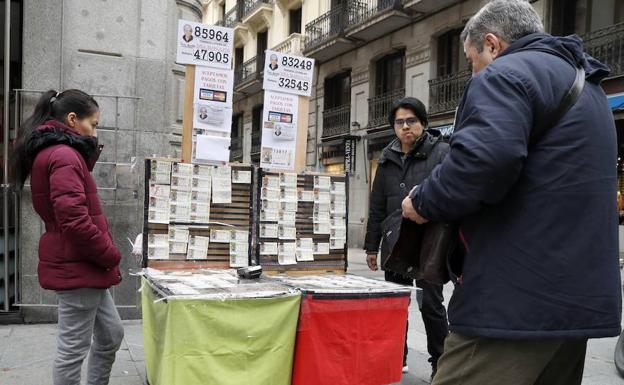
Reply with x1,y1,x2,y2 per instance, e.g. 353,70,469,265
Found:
460,0,544,52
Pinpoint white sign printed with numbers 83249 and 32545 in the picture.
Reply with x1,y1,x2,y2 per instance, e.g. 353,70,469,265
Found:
263,50,314,96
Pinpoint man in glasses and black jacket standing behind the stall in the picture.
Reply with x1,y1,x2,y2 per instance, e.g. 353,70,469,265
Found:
365,97,449,377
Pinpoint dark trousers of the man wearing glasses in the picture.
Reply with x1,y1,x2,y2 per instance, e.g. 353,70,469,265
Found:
385,271,448,368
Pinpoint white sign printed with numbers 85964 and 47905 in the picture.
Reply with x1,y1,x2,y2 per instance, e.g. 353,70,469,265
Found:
176,20,234,69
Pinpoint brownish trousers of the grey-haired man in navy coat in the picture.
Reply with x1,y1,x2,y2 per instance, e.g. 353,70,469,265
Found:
432,333,587,385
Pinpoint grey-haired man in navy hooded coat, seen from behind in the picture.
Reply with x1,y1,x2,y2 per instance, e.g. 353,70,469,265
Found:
403,0,621,385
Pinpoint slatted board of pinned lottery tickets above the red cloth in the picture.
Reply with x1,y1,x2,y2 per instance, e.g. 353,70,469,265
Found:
256,170,348,271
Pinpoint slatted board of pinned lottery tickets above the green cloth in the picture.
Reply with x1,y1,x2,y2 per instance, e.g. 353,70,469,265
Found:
143,158,255,269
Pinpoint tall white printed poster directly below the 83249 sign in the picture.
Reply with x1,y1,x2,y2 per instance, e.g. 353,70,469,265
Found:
260,91,299,170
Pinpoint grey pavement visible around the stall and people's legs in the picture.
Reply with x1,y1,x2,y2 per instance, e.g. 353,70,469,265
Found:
0,249,624,385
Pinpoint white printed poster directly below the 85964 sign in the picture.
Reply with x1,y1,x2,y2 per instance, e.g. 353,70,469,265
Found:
193,67,234,136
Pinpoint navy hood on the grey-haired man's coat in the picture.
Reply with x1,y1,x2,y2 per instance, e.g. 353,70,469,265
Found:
499,33,610,84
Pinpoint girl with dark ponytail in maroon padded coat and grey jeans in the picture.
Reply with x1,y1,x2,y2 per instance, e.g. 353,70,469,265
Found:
13,90,123,385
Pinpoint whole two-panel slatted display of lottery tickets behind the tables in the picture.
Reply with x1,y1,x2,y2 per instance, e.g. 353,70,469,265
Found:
143,158,348,272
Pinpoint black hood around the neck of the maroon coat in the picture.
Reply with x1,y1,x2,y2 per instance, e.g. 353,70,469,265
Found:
26,120,104,171
